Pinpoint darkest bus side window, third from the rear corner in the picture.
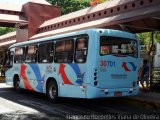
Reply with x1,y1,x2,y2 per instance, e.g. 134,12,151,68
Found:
38,43,54,63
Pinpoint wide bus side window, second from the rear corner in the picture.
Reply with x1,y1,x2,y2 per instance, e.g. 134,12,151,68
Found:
54,40,74,63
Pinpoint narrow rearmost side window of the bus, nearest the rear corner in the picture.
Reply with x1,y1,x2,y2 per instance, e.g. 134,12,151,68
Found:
75,37,88,63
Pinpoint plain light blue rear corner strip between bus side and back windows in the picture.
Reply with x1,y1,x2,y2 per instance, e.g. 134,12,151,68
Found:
86,31,100,98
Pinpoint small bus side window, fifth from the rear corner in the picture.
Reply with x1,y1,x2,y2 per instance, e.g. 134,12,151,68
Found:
14,47,25,63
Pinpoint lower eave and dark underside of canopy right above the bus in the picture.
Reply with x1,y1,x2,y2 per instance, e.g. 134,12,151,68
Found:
31,1,160,39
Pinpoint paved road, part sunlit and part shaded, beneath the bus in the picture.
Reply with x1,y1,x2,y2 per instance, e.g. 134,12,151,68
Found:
0,83,160,120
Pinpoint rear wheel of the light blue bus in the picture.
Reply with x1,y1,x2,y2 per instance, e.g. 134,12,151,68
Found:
47,81,58,102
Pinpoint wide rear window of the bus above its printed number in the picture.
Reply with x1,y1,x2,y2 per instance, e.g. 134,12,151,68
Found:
100,36,138,57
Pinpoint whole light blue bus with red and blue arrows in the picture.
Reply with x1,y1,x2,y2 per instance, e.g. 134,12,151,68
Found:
5,29,140,102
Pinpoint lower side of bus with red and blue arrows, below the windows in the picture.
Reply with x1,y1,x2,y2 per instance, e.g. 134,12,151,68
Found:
20,63,86,98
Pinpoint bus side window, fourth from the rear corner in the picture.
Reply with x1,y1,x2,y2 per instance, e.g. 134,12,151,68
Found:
25,45,38,63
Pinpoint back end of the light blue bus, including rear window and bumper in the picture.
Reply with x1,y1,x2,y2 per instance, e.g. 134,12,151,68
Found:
87,36,139,98
